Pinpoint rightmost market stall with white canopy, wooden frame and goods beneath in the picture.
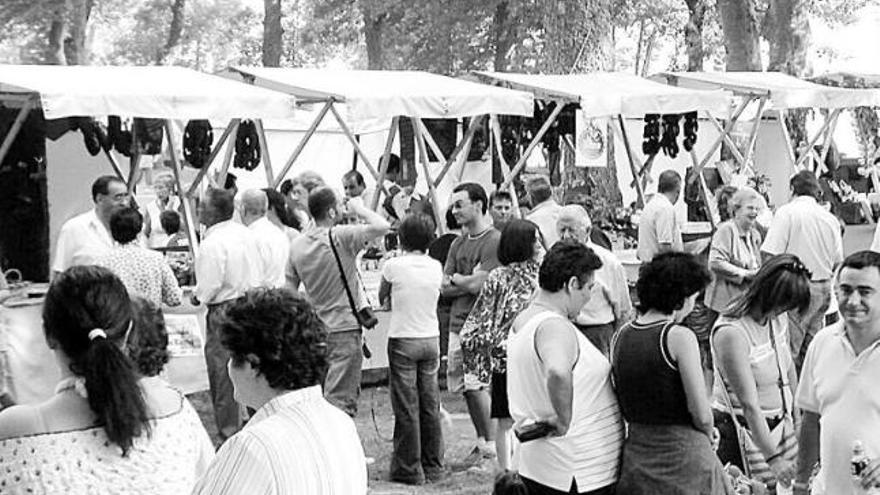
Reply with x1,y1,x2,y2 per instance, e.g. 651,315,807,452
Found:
654,72,880,204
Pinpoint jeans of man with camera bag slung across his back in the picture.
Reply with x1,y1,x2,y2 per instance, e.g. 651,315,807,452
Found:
324,329,363,417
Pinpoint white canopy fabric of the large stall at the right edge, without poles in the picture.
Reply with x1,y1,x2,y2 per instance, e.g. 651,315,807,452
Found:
653,72,880,110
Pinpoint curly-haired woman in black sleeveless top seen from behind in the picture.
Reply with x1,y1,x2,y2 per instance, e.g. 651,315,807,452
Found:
612,252,733,495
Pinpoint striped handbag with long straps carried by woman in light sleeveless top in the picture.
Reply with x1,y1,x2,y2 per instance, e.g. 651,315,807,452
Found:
712,319,798,488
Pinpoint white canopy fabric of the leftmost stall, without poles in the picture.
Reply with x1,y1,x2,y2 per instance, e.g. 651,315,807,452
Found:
0,65,296,120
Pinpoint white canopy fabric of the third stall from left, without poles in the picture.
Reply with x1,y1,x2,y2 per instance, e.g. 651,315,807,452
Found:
477,72,730,118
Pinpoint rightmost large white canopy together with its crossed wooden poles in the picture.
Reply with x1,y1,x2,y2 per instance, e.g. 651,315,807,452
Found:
654,72,880,193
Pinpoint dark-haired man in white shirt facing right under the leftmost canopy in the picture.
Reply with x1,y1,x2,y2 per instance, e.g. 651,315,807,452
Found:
52,175,131,277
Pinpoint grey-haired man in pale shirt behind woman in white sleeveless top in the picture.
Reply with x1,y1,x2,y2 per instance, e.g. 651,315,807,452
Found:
556,205,632,356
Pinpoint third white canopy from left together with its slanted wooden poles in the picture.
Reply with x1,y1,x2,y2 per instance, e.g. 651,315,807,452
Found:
476,72,730,225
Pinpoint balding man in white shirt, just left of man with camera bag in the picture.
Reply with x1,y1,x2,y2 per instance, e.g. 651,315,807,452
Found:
241,189,290,288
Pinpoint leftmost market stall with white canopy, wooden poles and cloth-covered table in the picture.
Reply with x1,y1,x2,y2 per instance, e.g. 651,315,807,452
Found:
0,65,295,403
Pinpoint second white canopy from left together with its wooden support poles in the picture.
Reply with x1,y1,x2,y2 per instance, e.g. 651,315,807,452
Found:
227,67,534,229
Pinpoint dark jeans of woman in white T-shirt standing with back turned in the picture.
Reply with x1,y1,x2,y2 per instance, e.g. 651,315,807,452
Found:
388,337,443,484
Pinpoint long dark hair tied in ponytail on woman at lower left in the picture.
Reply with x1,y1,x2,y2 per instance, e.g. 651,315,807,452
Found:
43,265,150,455
